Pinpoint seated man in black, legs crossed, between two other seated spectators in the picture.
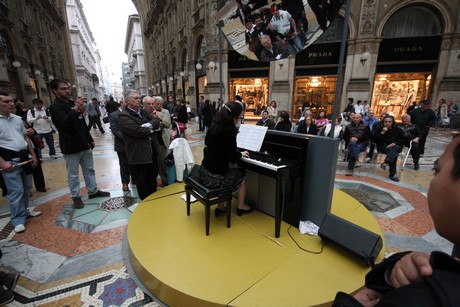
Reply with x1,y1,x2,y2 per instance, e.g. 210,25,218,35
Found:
373,115,405,182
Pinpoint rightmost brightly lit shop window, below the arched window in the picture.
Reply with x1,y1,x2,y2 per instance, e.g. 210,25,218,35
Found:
370,73,431,120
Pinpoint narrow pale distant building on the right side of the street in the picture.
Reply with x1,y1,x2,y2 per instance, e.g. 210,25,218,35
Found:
123,15,147,95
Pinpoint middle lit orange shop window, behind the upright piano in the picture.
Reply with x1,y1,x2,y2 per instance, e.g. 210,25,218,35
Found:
291,76,337,119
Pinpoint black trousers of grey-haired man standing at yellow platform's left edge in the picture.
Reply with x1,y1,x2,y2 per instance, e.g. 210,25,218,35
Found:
130,156,158,200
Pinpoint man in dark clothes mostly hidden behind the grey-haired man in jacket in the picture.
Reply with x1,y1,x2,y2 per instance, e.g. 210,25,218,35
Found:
109,99,135,192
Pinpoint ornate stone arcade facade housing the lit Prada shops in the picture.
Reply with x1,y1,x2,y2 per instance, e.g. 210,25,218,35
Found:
133,0,460,119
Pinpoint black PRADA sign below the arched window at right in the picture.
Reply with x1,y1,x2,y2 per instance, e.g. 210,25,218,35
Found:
378,36,441,62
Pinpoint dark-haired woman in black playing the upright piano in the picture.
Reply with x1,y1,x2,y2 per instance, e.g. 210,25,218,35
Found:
200,103,252,217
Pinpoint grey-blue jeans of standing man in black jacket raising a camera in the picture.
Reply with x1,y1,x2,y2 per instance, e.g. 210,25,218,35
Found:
64,149,97,199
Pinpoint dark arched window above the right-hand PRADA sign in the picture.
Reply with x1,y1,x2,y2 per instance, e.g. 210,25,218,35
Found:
382,6,443,38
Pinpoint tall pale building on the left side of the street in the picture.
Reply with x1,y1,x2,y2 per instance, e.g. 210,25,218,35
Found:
66,0,105,100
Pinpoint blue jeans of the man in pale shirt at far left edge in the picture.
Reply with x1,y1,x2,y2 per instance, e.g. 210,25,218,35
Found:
2,167,32,226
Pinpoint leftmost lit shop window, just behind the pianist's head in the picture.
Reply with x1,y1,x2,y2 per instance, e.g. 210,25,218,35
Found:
230,78,269,117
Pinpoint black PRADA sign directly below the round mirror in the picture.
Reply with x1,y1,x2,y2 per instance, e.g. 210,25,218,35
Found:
295,43,340,66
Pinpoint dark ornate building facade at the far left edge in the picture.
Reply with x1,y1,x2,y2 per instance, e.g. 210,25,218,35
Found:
0,0,75,107
